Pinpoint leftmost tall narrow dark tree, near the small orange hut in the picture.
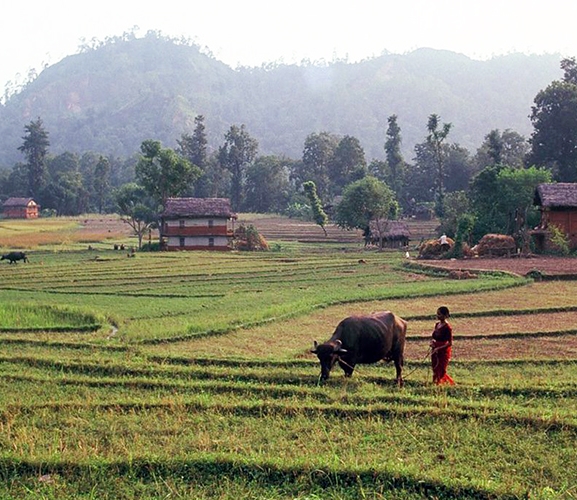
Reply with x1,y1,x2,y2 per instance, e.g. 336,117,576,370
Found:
18,117,50,198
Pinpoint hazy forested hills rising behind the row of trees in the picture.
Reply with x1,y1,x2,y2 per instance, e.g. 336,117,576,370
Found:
0,34,562,166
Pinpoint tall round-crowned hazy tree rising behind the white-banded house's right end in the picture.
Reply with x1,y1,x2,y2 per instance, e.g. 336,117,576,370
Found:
218,125,258,210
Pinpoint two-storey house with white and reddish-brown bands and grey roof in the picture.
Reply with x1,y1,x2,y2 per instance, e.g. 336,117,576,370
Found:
160,198,236,250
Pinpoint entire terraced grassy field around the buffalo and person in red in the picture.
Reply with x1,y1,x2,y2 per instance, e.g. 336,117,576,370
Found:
0,217,577,500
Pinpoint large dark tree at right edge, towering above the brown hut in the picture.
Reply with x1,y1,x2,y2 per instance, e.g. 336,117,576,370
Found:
529,58,577,182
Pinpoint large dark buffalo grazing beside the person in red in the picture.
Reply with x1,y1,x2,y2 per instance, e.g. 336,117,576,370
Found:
311,311,407,387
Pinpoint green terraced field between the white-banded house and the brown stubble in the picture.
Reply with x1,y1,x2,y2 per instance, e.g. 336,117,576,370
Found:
0,250,527,343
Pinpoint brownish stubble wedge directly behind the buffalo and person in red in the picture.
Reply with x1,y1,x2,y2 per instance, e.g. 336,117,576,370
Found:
163,281,577,361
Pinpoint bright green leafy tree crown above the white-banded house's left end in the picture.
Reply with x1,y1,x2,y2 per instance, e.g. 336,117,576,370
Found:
136,140,200,205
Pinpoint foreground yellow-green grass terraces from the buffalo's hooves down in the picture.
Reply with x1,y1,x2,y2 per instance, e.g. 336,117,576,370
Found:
0,348,577,498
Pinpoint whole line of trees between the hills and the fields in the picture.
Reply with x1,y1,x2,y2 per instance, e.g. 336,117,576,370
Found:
0,58,577,249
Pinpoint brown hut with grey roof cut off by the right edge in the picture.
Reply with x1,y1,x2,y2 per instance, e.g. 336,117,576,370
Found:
532,182,577,250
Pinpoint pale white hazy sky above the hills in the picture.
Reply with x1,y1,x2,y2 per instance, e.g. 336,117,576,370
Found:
0,0,577,90
